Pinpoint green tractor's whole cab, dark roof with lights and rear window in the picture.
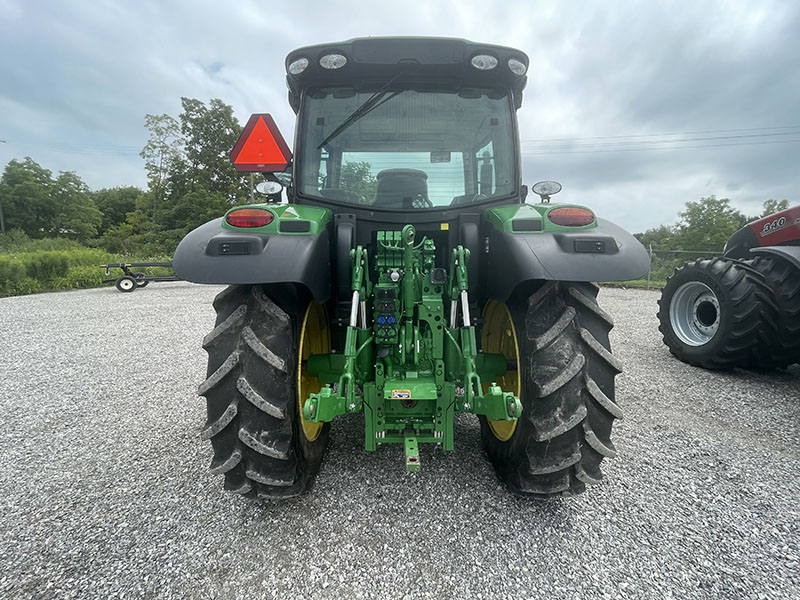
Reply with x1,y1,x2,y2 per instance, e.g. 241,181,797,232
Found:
286,38,528,220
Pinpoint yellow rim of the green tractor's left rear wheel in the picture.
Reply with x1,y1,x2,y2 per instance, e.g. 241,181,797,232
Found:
297,300,331,442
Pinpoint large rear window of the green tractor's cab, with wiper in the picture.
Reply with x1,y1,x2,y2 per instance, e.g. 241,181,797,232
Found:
295,81,519,211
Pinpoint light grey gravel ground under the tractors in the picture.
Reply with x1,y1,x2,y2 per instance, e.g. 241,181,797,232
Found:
0,283,800,599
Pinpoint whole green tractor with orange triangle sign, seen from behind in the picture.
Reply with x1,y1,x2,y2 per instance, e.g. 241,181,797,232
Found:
174,38,648,499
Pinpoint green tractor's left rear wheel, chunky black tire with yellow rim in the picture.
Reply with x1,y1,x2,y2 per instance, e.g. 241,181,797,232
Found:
198,286,330,499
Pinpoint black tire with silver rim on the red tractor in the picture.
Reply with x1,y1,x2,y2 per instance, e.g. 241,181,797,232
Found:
658,258,776,369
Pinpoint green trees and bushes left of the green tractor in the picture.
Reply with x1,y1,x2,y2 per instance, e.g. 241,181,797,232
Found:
0,98,248,256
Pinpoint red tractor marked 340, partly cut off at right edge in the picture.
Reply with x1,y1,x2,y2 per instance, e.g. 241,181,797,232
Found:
658,205,800,369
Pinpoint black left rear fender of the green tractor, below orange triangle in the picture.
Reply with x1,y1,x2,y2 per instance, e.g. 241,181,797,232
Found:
172,218,331,303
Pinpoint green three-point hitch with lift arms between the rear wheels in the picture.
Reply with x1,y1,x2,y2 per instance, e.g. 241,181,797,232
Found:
303,225,522,471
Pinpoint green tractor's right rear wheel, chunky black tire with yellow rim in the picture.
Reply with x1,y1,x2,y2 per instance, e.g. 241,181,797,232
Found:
480,281,622,497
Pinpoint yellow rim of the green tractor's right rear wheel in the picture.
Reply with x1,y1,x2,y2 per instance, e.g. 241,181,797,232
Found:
481,300,522,442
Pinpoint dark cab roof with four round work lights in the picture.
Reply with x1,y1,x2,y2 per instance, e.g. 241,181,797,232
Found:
286,37,529,112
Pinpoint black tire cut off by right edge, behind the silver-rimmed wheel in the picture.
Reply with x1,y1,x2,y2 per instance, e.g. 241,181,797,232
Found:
753,256,800,367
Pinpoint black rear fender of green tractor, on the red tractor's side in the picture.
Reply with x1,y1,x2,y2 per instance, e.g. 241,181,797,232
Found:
487,219,650,301
